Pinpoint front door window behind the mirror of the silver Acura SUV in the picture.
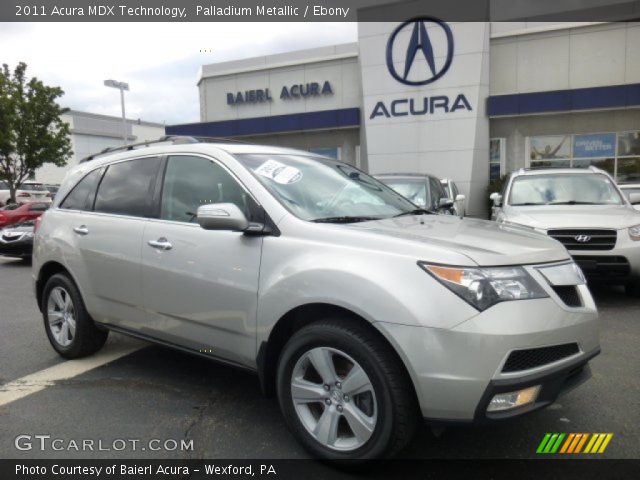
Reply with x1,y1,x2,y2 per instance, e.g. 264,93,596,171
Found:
160,155,253,222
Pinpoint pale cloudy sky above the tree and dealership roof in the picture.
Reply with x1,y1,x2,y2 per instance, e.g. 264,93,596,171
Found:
0,22,357,125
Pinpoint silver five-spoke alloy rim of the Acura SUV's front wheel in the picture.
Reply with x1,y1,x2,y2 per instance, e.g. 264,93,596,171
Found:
291,347,377,451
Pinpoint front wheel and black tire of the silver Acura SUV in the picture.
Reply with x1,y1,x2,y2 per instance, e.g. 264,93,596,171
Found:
277,318,419,461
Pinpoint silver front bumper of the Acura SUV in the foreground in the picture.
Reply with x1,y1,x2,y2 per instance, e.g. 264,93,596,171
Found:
375,285,600,423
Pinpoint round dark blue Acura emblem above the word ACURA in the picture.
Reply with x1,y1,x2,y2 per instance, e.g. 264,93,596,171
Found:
387,17,453,86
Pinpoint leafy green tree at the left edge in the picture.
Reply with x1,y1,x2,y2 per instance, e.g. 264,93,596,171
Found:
0,62,72,202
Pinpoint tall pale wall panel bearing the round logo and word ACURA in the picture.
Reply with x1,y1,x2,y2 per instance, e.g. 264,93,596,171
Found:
358,13,490,215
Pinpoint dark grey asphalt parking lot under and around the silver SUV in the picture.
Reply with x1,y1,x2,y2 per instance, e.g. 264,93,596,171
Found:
0,255,640,459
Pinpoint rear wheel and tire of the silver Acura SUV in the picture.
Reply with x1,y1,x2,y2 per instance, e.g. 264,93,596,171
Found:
42,273,109,358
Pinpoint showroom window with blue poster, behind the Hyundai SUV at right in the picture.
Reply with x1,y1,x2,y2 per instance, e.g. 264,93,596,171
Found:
527,131,640,182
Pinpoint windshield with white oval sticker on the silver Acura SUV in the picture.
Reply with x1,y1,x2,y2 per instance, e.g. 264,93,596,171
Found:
236,154,416,222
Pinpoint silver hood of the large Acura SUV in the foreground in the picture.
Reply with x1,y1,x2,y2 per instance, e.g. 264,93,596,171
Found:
342,215,569,266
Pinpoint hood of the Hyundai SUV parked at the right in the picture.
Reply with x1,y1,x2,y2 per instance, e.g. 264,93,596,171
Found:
504,205,640,230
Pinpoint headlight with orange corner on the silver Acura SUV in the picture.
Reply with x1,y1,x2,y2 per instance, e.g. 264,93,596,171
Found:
418,262,548,311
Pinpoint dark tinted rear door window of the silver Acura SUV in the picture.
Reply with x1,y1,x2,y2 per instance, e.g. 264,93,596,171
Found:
95,158,160,217
